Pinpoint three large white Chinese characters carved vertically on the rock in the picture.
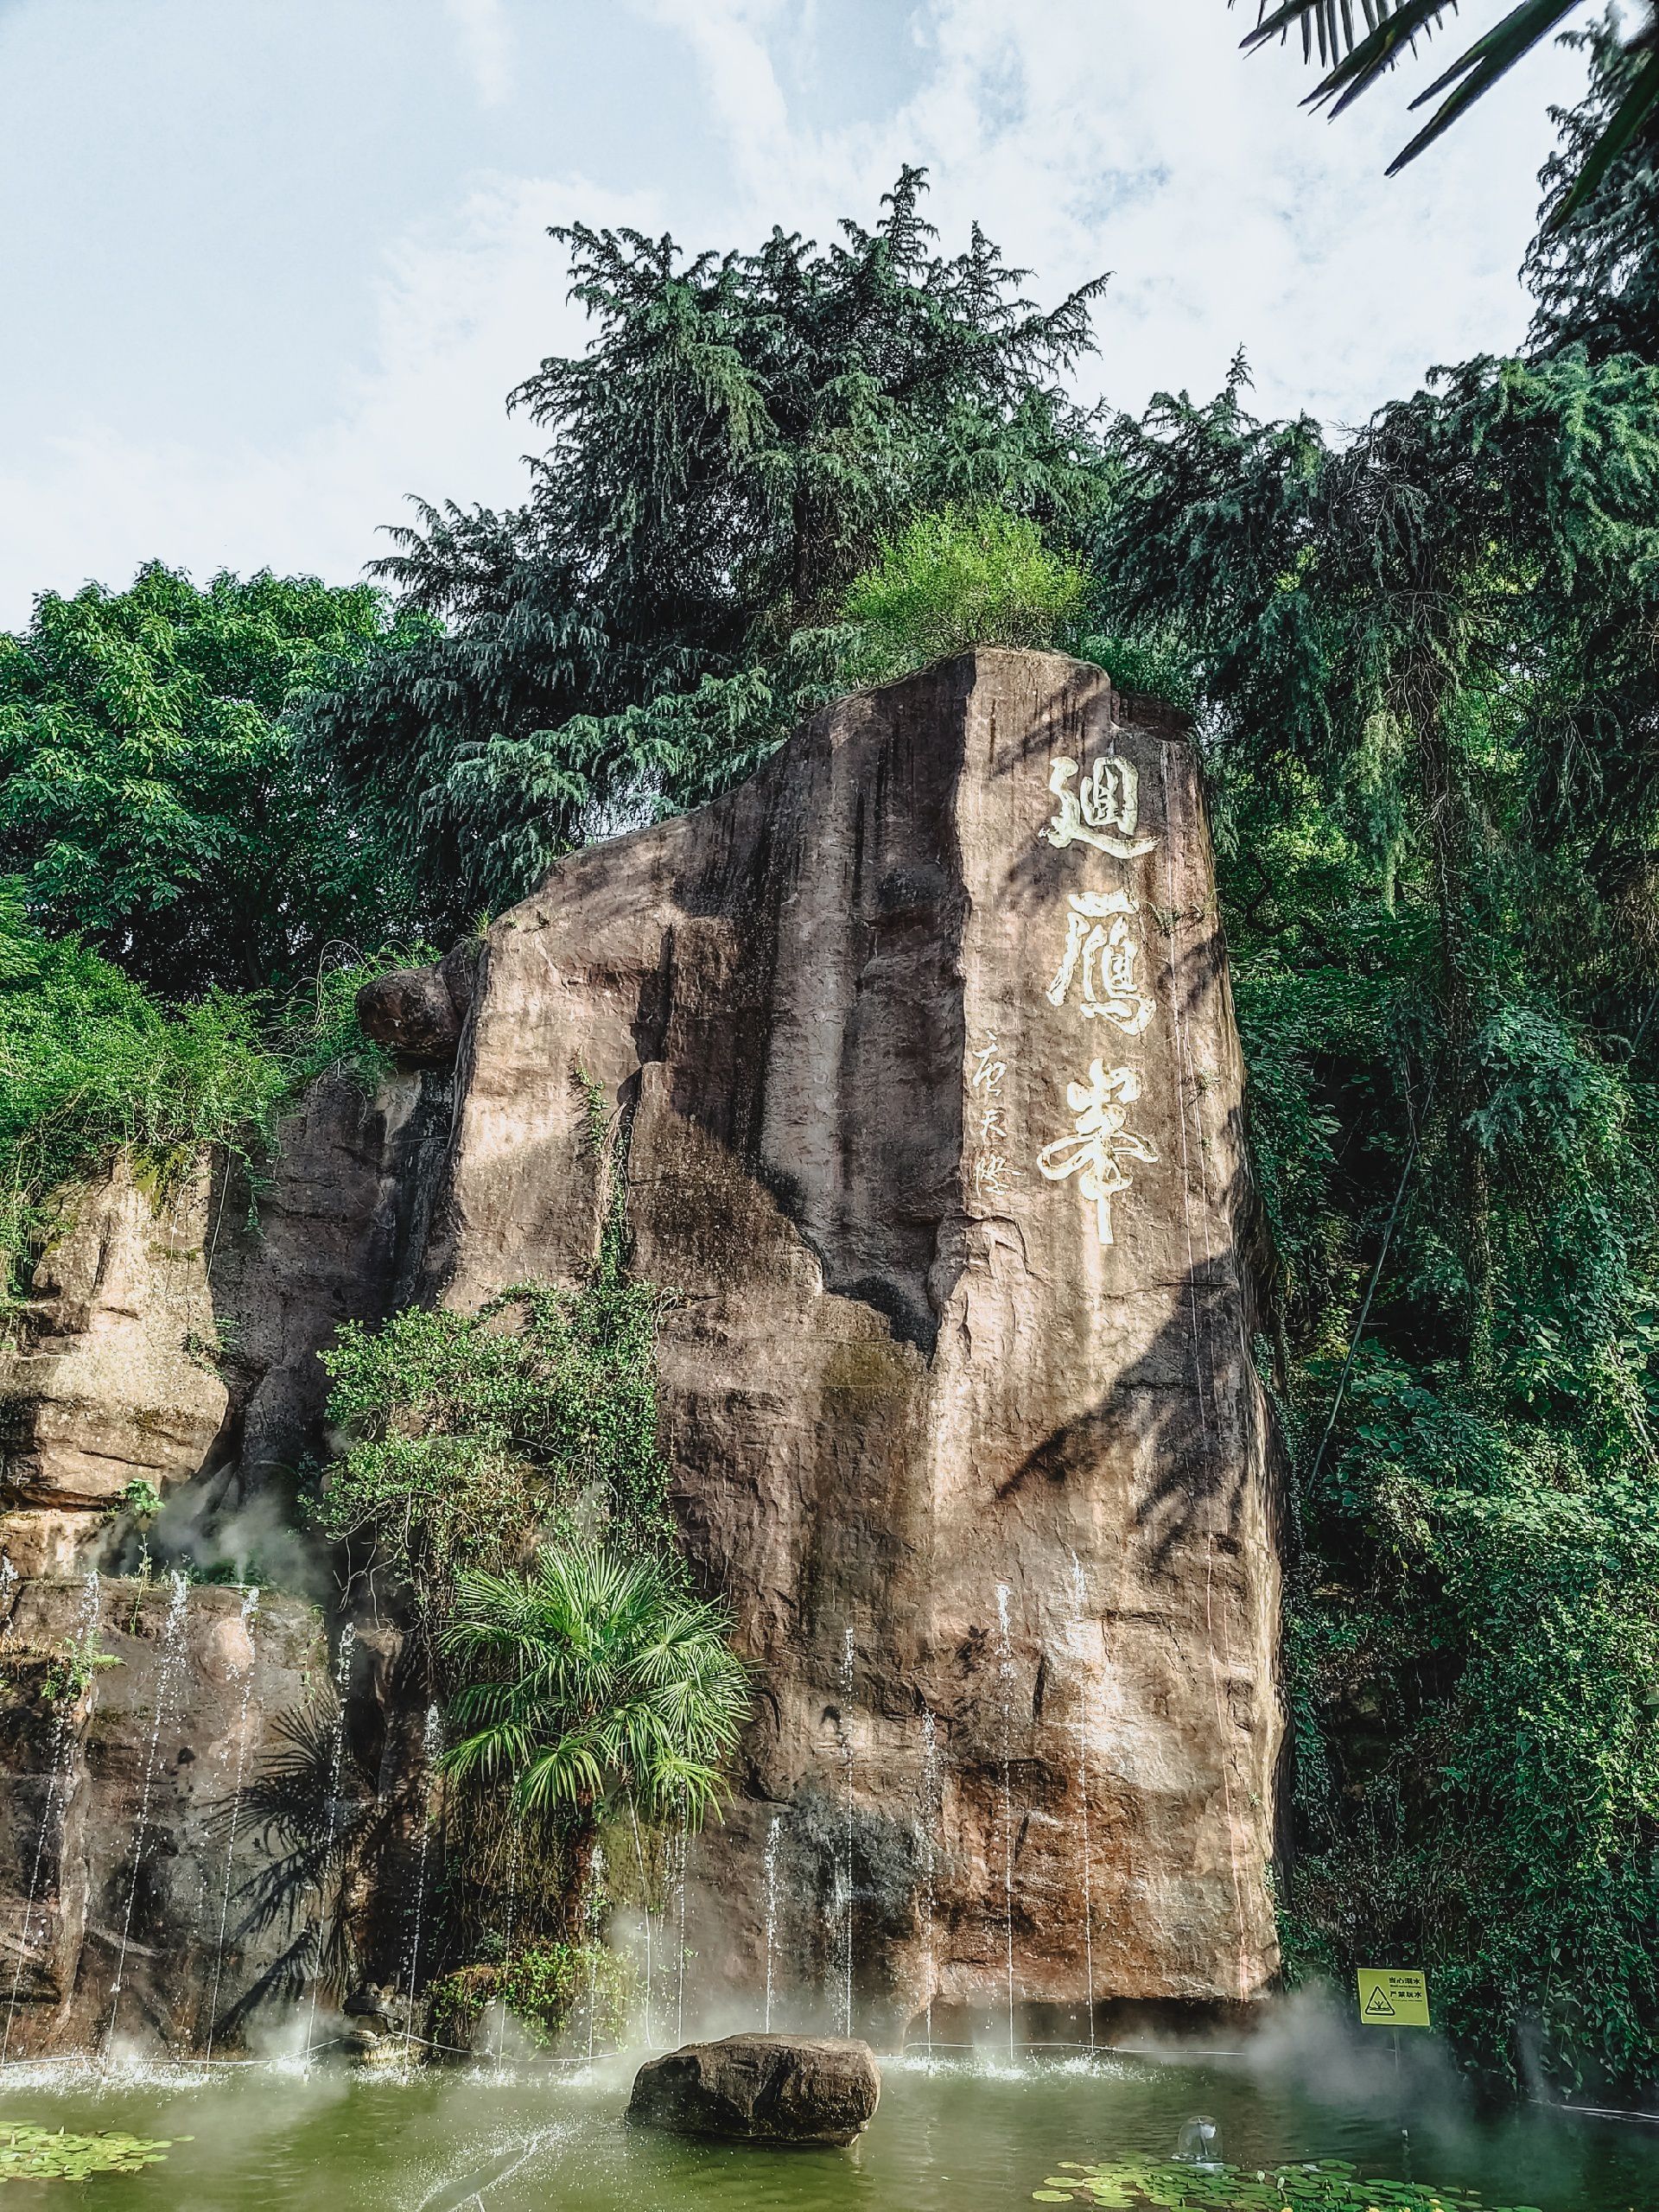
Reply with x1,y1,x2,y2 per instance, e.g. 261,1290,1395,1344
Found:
1038,752,1157,1245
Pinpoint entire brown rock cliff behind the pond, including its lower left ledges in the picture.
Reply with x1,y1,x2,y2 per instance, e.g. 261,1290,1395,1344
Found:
0,652,1281,2049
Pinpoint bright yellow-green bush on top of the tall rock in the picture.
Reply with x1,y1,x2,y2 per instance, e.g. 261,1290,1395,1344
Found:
841,506,1089,681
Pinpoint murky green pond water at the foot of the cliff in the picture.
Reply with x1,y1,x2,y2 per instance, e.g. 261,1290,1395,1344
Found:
0,2039,1659,2212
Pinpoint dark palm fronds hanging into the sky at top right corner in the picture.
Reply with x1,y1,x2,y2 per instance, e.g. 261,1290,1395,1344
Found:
1228,0,1659,228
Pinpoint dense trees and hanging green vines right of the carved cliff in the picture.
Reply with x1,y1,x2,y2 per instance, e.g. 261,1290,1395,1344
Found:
1097,321,1659,2086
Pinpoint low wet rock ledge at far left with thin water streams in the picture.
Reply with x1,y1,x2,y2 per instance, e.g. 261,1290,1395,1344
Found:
0,1577,327,2059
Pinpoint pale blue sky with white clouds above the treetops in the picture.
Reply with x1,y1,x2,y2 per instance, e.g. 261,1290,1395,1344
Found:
0,0,1584,628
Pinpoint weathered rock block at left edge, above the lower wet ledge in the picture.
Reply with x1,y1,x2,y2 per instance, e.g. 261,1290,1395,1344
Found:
0,1071,449,1577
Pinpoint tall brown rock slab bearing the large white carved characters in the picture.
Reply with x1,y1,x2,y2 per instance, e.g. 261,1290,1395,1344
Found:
427,652,1281,2035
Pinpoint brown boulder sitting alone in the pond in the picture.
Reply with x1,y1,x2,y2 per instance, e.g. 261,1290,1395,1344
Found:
628,2035,880,2144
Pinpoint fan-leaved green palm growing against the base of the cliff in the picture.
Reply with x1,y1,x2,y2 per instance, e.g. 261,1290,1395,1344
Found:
440,1540,750,1822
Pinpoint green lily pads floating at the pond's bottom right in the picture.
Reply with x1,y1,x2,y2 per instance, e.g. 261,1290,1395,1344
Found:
1031,2159,1535,2212
